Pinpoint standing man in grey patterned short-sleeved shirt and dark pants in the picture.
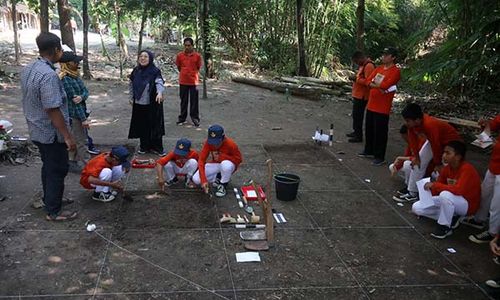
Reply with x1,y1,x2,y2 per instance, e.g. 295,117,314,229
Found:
21,32,77,221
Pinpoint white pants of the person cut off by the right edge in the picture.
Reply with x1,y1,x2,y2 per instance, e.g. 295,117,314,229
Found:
474,170,500,235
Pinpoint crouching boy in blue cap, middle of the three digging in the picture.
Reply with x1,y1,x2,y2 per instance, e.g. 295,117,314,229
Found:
156,139,198,190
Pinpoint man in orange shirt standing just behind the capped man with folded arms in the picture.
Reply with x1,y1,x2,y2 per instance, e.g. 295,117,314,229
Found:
346,51,375,143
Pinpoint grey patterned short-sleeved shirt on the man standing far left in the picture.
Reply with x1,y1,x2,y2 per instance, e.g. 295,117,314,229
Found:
21,58,69,144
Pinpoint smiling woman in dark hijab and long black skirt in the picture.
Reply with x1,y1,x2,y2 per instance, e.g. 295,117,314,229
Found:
128,50,165,156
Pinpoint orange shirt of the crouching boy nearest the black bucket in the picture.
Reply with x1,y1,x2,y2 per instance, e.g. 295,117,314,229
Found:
198,137,242,184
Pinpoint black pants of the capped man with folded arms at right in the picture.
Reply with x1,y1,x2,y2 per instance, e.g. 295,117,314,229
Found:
364,110,389,160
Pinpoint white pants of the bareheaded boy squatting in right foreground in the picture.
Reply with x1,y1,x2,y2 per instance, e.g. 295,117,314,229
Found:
411,191,469,227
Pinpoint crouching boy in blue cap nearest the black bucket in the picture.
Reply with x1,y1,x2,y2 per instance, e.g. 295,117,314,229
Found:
193,125,242,197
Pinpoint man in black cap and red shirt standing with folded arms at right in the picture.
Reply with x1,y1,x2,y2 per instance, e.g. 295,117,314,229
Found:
358,48,401,166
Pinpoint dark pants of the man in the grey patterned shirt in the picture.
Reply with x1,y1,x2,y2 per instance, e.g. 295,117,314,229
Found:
33,141,68,215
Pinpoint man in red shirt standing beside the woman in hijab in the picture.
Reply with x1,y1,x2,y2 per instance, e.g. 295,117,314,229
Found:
175,38,201,127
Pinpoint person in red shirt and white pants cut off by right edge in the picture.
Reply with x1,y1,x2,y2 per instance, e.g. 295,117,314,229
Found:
462,115,500,244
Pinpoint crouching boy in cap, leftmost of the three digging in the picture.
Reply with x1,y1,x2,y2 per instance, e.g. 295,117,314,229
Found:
80,146,130,202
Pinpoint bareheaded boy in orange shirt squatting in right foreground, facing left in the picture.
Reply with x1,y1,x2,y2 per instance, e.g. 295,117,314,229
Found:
412,141,481,239
